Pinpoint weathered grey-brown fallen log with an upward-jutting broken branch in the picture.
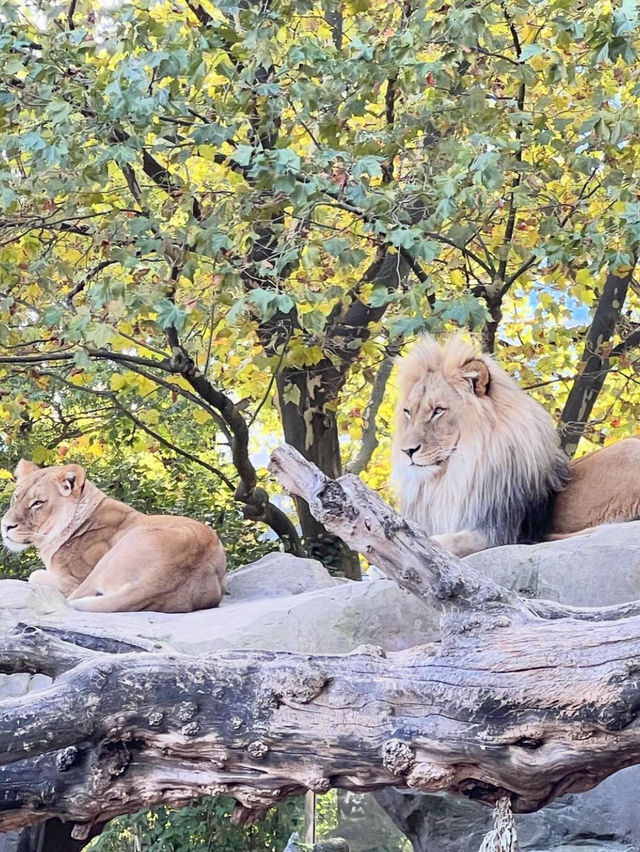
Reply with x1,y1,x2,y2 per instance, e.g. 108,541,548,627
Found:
0,447,640,834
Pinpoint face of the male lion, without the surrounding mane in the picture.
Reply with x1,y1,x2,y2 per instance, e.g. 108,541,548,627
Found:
394,373,465,474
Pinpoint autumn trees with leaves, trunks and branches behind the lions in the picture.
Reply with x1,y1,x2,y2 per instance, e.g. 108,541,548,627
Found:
0,0,640,576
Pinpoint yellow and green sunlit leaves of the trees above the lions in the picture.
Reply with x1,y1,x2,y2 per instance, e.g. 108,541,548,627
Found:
0,0,640,492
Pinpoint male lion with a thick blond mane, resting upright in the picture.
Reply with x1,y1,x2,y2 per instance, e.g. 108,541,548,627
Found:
392,336,640,556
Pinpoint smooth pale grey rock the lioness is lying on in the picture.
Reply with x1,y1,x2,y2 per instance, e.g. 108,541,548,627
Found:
0,553,439,656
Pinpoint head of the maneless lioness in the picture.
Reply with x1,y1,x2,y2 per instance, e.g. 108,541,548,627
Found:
1,459,85,553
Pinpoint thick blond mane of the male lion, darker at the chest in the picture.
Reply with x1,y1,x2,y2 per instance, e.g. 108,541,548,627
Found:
392,337,568,546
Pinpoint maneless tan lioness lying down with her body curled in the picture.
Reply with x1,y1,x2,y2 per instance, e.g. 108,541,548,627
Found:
1,459,226,612
